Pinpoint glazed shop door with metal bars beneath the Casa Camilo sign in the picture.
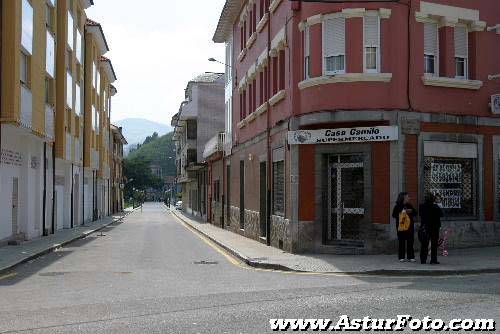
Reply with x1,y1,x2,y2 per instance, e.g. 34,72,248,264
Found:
327,154,365,243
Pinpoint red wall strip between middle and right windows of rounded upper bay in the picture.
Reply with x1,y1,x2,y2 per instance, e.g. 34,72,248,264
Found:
345,17,364,73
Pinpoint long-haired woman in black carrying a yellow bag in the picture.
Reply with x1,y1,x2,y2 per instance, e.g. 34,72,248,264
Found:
392,192,417,262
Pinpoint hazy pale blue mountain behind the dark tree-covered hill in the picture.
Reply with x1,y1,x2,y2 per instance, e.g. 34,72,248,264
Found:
114,118,172,152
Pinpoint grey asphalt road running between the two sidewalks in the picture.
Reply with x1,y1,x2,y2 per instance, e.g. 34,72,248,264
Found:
0,204,500,333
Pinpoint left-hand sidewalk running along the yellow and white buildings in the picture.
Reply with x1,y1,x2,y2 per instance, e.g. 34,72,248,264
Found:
0,209,133,274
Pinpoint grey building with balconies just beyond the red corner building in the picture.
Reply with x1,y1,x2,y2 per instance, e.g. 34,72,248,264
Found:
171,73,224,220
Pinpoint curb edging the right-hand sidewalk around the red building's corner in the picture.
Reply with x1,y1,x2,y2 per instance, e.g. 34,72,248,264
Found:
170,210,500,277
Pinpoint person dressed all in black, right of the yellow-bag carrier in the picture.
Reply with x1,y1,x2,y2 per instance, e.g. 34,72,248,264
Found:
418,194,443,264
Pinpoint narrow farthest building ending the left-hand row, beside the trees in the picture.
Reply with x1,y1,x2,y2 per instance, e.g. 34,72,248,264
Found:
110,124,128,213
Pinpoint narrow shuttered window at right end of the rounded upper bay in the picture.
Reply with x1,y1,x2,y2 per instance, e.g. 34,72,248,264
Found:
364,12,380,73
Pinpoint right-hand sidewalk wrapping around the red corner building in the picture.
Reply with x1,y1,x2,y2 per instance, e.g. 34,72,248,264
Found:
171,209,500,276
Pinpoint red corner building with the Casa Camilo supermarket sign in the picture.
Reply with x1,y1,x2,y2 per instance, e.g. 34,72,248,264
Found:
213,0,500,254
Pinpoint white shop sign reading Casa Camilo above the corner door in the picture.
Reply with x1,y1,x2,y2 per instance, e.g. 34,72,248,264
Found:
288,126,399,145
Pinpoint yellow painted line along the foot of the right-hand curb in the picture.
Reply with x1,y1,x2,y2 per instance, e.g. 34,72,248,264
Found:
169,212,497,279
